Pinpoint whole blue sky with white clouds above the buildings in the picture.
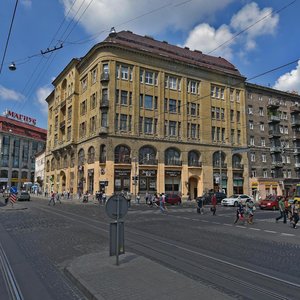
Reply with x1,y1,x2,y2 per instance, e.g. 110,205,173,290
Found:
0,0,300,128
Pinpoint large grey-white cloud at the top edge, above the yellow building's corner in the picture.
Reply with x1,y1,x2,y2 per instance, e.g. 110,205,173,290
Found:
60,0,234,34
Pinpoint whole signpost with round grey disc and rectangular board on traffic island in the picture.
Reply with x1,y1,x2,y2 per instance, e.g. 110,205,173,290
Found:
105,195,128,266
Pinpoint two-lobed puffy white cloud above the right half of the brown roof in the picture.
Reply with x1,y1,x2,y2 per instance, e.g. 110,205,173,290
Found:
185,2,279,60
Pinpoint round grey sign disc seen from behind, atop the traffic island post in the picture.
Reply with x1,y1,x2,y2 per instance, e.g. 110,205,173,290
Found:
105,195,128,220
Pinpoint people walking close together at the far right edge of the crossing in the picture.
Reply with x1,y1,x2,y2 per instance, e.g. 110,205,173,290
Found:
275,198,299,229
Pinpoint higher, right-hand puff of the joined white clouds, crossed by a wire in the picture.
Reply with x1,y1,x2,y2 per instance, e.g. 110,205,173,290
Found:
230,2,279,50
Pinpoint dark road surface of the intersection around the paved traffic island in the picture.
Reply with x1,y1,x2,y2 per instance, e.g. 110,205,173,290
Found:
0,199,300,300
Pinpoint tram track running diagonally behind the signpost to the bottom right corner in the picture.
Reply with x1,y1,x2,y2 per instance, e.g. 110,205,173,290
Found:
37,205,300,300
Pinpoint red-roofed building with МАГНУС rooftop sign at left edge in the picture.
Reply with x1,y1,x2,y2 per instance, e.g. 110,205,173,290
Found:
0,111,47,190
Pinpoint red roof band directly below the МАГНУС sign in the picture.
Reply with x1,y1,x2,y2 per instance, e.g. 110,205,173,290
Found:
0,116,47,141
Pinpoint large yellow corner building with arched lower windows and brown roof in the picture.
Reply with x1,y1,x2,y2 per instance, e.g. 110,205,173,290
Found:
46,31,249,199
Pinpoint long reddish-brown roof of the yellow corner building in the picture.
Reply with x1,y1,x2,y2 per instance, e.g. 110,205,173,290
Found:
99,31,242,77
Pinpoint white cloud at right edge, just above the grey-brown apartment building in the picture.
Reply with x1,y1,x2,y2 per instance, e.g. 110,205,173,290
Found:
273,60,300,94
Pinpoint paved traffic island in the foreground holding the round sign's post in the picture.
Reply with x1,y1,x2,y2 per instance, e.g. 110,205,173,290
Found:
64,250,233,300
